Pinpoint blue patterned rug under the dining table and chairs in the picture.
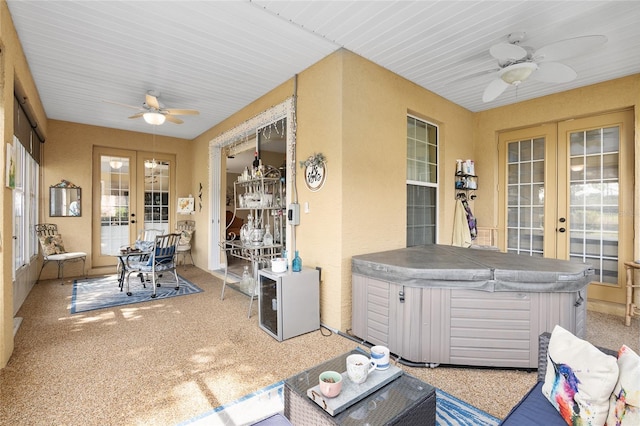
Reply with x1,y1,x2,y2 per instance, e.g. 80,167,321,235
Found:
71,274,203,314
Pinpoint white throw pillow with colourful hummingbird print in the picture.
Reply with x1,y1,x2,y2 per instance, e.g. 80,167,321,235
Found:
542,325,618,426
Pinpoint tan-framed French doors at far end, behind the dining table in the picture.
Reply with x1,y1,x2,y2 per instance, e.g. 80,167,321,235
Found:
92,147,175,267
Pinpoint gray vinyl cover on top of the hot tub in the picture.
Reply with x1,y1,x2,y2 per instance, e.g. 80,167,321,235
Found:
352,244,594,293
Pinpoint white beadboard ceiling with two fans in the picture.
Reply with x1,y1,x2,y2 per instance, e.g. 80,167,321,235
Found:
7,0,640,139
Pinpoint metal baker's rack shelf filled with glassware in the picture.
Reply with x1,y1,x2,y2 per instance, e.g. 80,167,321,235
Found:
221,175,286,317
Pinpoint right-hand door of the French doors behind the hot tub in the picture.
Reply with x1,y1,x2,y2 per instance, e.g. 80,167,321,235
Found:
558,112,634,303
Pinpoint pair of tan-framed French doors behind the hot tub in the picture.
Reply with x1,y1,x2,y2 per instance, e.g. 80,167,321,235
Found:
499,111,634,303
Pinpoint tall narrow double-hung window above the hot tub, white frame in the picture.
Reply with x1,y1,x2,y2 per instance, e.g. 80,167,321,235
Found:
407,116,438,247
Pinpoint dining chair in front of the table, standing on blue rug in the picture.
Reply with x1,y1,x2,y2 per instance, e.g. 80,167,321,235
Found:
125,234,180,298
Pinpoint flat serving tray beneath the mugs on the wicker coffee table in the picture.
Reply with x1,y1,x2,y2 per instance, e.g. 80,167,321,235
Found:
307,365,402,416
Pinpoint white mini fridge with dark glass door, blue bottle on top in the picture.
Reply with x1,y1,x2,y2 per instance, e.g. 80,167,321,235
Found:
258,268,320,341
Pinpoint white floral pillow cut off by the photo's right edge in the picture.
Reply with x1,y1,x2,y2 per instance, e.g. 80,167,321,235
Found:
607,345,640,426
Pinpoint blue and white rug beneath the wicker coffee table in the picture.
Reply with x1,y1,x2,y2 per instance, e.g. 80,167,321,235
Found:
180,381,500,426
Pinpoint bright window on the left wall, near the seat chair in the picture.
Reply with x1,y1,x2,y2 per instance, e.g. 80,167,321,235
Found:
13,137,39,277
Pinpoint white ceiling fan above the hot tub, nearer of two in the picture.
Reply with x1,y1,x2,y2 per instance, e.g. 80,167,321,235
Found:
482,32,607,102
